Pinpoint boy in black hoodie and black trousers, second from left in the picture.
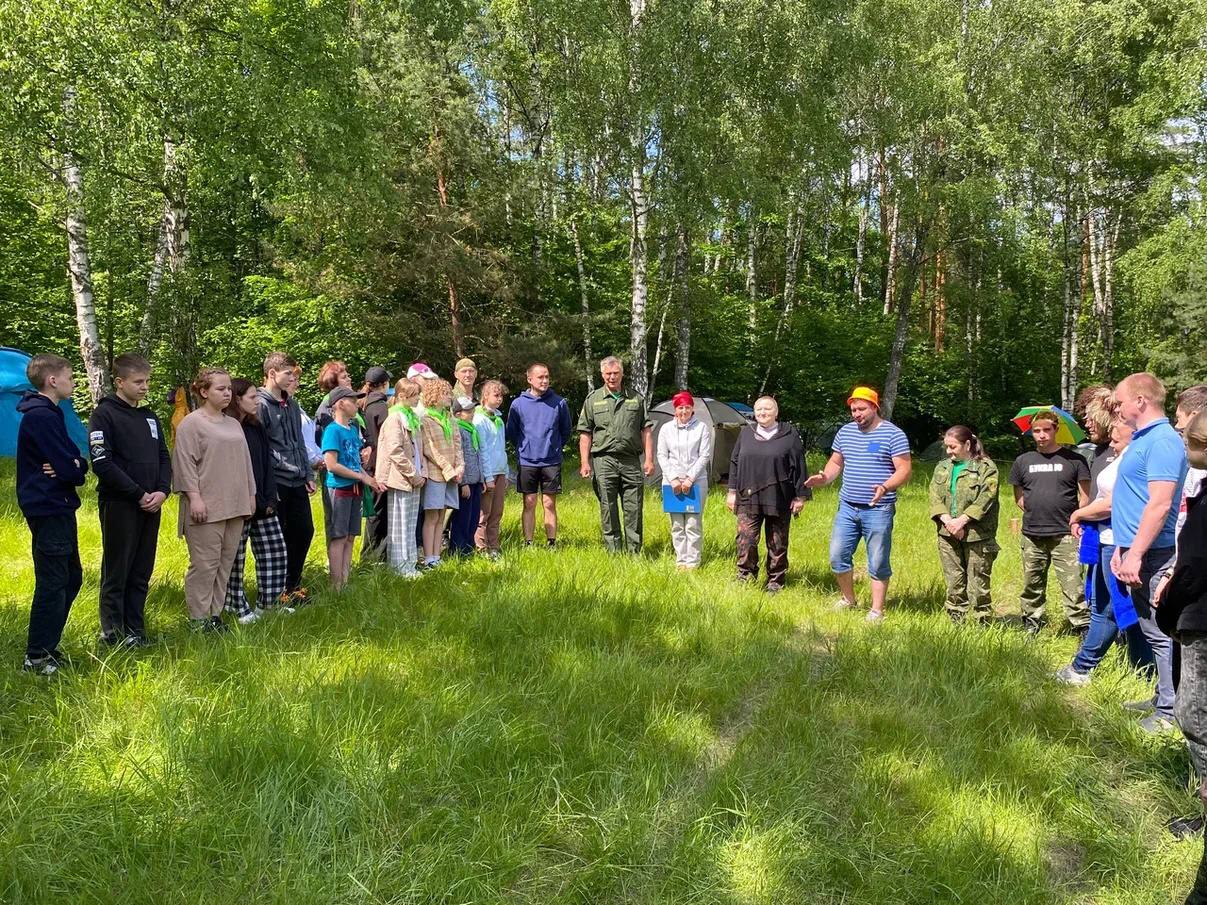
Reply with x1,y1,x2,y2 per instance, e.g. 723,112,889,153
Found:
88,355,171,647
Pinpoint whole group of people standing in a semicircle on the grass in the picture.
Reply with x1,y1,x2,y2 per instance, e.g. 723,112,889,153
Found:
17,352,1207,903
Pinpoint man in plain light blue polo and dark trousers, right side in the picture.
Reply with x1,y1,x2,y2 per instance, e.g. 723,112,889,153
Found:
1110,373,1186,732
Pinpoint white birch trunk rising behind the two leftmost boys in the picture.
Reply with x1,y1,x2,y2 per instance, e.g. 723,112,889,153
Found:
62,88,110,404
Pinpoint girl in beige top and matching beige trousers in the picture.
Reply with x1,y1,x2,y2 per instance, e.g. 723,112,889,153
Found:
171,368,256,631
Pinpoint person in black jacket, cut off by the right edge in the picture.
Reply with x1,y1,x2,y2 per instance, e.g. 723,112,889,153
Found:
1156,411,1207,905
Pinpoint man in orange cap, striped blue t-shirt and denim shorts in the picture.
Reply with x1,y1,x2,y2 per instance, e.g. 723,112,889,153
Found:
805,386,911,623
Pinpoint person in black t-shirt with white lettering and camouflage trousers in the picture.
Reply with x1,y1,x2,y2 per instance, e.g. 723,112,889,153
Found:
1010,411,1090,635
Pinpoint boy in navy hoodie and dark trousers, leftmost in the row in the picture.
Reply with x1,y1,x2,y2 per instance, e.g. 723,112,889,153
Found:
17,355,88,676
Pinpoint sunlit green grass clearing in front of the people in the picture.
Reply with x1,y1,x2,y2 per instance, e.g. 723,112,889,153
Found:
0,467,1201,905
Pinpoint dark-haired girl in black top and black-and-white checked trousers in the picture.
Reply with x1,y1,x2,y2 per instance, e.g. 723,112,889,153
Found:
226,378,293,625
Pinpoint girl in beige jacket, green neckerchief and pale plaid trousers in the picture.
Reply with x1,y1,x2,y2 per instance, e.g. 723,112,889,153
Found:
374,378,425,578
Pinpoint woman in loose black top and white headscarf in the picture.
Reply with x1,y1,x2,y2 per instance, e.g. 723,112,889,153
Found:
725,396,812,594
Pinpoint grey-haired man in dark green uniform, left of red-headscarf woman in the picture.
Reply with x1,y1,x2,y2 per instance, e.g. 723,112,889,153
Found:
578,356,654,553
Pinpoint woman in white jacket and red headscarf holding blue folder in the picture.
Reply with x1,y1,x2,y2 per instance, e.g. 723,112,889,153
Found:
658,390,712,570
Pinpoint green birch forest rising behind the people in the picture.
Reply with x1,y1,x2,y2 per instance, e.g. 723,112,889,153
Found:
0,0,1207,445
